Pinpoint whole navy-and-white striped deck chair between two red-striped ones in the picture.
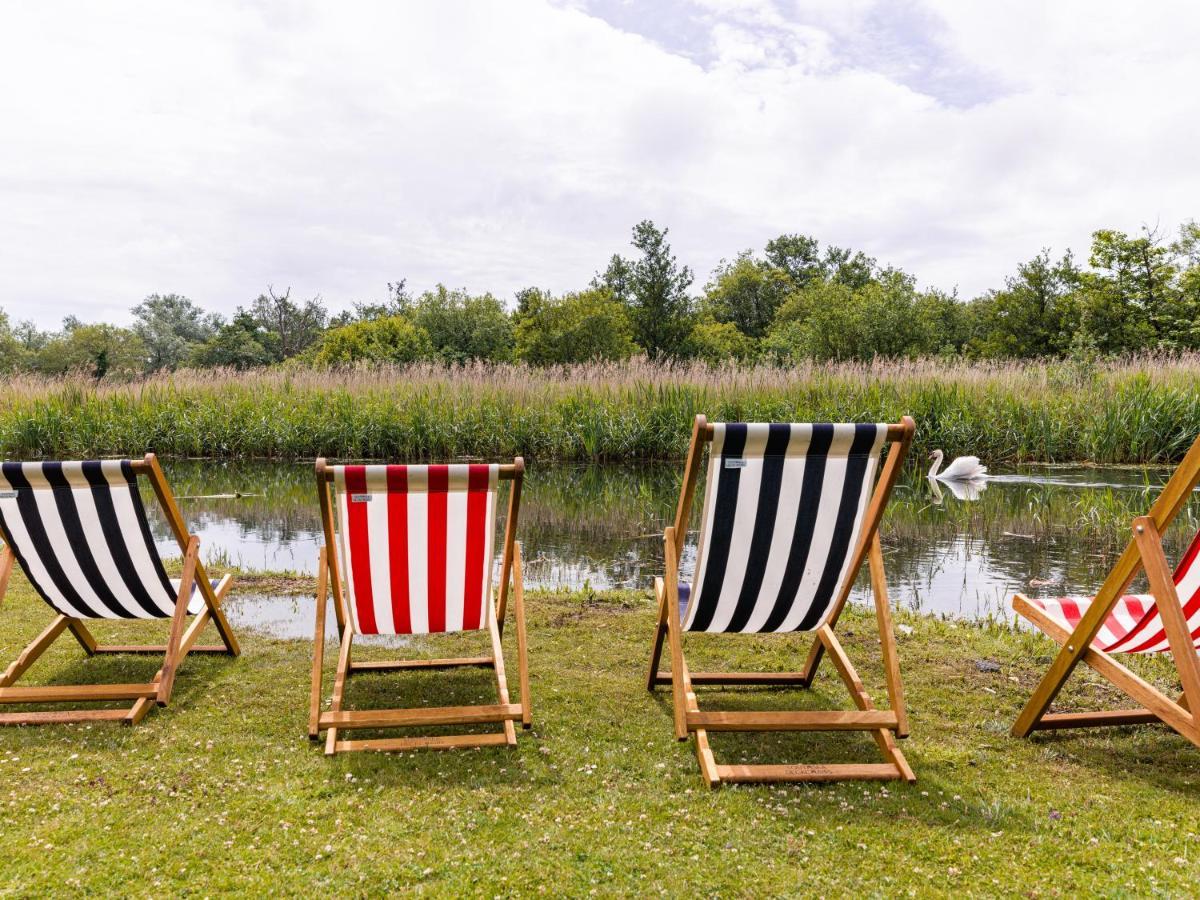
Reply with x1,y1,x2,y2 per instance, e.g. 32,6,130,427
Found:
647,415,916,787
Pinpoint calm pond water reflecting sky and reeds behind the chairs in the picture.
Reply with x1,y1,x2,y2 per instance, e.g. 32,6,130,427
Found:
148,460,1198,637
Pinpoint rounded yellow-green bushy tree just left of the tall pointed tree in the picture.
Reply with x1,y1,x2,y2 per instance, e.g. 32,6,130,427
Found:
516,288,637,365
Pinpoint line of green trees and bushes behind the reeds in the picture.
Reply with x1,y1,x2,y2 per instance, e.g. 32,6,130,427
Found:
0,221,1200,378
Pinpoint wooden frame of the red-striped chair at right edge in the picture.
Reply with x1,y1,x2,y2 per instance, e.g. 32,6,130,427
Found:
1013,438,1200,746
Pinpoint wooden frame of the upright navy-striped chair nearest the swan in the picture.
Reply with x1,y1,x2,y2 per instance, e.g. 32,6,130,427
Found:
647,415,916,787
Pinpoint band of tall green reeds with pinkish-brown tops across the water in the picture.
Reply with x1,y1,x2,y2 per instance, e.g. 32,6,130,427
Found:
0,354,1200,464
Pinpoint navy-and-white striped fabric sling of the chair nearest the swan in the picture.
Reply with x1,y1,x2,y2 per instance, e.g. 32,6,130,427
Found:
679,424,888,634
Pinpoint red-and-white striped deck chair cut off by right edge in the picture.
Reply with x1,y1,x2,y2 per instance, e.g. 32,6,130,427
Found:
1013,429,1200,746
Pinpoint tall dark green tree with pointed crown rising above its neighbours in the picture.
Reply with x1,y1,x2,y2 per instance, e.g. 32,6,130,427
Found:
593,220,692,359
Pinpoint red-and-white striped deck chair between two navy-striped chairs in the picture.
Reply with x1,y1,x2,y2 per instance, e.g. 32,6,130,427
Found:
308,456,533,755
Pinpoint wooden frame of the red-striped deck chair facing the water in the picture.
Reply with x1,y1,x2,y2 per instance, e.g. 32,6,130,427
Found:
308,456,533,756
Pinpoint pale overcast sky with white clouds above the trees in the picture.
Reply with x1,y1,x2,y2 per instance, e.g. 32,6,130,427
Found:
0,0,1200,326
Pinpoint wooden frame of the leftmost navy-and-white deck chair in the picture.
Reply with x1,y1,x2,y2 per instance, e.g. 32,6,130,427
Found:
0,454,241,725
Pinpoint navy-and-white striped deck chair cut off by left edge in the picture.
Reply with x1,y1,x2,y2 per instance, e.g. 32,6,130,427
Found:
0,454,240,725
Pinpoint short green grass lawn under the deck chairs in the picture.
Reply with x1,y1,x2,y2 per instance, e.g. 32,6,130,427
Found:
0,575,1200,895
